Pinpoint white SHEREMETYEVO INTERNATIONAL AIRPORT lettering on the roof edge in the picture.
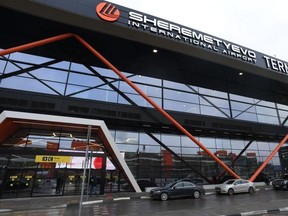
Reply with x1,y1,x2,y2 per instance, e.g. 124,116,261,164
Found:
127,11,257,64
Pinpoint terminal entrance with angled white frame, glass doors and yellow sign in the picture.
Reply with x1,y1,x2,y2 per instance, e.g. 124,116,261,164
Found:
0,112,141,198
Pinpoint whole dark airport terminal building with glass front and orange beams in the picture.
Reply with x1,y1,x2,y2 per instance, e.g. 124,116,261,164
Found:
0,0,288,198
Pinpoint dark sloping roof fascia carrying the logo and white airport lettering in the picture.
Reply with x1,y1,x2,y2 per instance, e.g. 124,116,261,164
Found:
35,0,288,74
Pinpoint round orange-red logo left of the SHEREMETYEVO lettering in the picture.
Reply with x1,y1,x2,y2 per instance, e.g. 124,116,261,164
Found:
96,2,120,22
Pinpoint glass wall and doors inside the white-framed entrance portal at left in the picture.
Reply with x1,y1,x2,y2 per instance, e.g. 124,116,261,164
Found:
0,123,112,198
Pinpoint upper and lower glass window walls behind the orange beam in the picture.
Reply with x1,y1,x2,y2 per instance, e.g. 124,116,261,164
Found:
0,49,288,185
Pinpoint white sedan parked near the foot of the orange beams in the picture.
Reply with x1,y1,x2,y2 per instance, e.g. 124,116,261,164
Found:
215,179,256,195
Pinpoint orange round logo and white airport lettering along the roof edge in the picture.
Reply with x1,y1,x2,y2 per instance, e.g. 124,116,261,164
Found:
96,2,288,74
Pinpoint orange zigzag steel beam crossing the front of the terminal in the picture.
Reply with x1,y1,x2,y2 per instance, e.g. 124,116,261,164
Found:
0,33,288,181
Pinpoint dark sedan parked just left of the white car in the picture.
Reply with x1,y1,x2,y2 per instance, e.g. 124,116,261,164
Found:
150,180,205,201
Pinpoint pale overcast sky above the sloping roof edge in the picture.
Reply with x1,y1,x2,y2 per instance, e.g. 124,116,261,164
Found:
110,0,288,62
